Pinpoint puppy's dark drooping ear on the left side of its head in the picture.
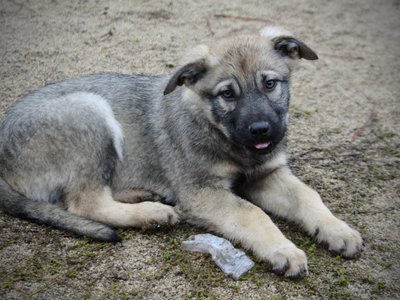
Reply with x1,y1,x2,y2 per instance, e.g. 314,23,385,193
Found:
164,59,206,95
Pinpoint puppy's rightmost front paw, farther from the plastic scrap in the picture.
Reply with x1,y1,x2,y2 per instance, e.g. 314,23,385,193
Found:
315,219,364,258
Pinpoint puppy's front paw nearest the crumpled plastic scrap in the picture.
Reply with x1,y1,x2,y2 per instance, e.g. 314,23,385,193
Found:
267,244,308,279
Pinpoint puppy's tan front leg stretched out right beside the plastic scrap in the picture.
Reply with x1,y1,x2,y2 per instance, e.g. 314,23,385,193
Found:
177,188,307,277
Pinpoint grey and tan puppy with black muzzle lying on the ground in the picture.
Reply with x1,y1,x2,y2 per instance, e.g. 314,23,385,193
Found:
0,27,363,277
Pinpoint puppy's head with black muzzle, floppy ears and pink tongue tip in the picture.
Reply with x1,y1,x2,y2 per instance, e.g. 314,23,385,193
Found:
164,27,318,154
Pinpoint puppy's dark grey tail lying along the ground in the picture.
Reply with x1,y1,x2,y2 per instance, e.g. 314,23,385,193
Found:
0,177,121,242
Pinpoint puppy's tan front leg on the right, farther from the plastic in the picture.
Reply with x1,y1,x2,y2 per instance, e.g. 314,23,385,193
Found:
246,166,363,258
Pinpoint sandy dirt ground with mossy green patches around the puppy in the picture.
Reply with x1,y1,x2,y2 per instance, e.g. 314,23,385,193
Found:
0,0,400,300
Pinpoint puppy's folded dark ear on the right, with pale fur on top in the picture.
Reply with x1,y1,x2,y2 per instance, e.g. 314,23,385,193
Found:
260,27,318,60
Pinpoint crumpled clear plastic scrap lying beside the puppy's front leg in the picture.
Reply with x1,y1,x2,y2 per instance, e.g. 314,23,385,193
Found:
182,233,254,280
